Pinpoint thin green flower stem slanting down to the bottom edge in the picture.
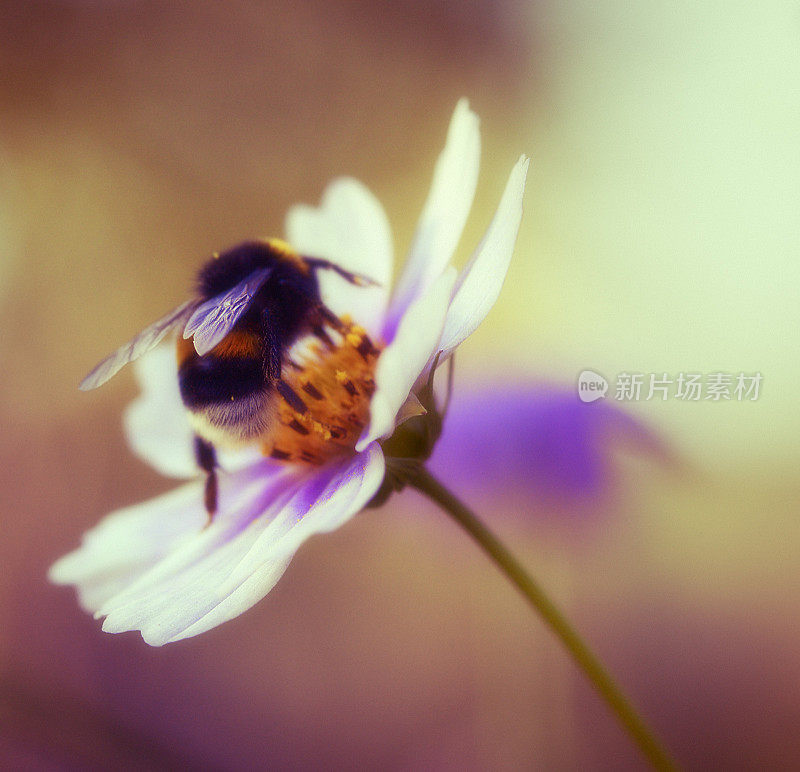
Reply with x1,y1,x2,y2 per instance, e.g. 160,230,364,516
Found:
403,465,675,770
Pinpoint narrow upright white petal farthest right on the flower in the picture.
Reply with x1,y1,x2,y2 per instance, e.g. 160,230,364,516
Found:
439,156,529,355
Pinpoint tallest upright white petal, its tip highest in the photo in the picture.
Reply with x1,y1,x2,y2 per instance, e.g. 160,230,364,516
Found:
384,99,481,340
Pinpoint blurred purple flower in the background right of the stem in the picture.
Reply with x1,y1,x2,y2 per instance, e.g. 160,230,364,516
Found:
430,384,664,510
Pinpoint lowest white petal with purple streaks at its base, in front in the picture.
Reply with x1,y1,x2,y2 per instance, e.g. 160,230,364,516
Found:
100,444,384,646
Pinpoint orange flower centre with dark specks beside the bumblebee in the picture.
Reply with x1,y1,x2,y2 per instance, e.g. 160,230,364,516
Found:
262,317,381,464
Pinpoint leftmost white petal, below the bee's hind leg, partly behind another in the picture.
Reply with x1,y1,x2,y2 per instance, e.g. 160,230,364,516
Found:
49,482,206,612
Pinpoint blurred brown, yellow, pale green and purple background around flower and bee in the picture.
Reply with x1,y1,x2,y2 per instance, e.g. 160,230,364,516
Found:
0,0,800,769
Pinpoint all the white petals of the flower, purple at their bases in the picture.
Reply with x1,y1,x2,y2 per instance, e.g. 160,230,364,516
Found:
50,100,528,646
